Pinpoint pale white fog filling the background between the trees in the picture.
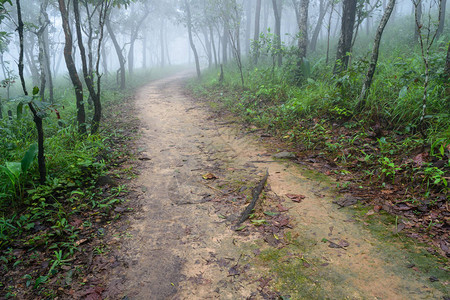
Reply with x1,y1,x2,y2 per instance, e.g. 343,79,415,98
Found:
0,0,446,94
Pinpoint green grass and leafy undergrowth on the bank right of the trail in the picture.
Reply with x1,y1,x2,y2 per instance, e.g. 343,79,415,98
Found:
190,10,450,256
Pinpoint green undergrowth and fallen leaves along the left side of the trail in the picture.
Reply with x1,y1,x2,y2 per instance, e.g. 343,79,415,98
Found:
0,68,182,299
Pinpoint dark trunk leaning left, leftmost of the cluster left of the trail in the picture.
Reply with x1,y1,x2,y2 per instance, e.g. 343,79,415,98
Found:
58,0,86,134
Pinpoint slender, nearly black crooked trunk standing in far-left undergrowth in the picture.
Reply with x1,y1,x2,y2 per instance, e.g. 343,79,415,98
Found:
16,0,47,184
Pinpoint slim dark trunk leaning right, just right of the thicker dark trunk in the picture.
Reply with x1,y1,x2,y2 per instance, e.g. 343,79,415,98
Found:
357,0,395,110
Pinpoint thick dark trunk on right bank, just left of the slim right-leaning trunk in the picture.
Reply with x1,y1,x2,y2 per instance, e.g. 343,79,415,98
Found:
333,0,357,74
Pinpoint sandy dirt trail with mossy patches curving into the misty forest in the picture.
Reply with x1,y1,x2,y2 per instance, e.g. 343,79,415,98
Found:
106,75,445,299
